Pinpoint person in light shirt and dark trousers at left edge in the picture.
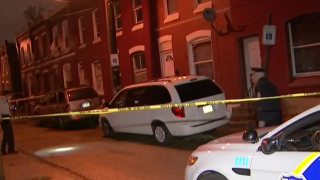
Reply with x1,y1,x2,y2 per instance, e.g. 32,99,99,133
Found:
0,91,17,155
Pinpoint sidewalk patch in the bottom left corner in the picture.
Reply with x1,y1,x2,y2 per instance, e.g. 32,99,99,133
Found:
2,154,78,180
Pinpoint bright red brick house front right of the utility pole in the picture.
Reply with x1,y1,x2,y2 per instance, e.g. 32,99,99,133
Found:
107,0,320,117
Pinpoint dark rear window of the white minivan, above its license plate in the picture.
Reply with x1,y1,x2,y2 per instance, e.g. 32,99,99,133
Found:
175,79,223,103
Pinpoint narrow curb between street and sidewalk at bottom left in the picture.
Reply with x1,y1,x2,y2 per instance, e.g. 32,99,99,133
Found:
16,147,98,180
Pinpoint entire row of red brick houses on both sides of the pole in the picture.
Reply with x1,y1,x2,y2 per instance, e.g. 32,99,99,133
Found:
13,0,320,114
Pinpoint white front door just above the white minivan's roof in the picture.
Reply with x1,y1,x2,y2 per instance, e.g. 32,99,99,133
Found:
161,50,175,77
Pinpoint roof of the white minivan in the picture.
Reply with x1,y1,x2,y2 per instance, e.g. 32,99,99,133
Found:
124,75,210,89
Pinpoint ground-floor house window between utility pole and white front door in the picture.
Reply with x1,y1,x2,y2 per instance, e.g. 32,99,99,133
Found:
131,51,148,83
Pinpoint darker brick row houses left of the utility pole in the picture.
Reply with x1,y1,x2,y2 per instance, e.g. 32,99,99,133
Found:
16,0,112,107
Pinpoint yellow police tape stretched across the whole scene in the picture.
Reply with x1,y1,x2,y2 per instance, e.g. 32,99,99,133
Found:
2,92,320,120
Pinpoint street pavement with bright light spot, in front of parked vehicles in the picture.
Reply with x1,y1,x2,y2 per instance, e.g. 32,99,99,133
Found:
4,120,243,180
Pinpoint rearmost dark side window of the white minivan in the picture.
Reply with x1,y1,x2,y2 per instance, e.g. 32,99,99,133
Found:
147,86,172,105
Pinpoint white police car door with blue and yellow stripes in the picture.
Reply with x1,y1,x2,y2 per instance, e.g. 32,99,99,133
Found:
251,151,320,180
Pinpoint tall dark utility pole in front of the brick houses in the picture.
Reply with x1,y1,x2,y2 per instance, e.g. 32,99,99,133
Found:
105,0,121,94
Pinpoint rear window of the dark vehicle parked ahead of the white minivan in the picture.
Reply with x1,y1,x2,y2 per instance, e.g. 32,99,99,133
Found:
68,87,99,101
